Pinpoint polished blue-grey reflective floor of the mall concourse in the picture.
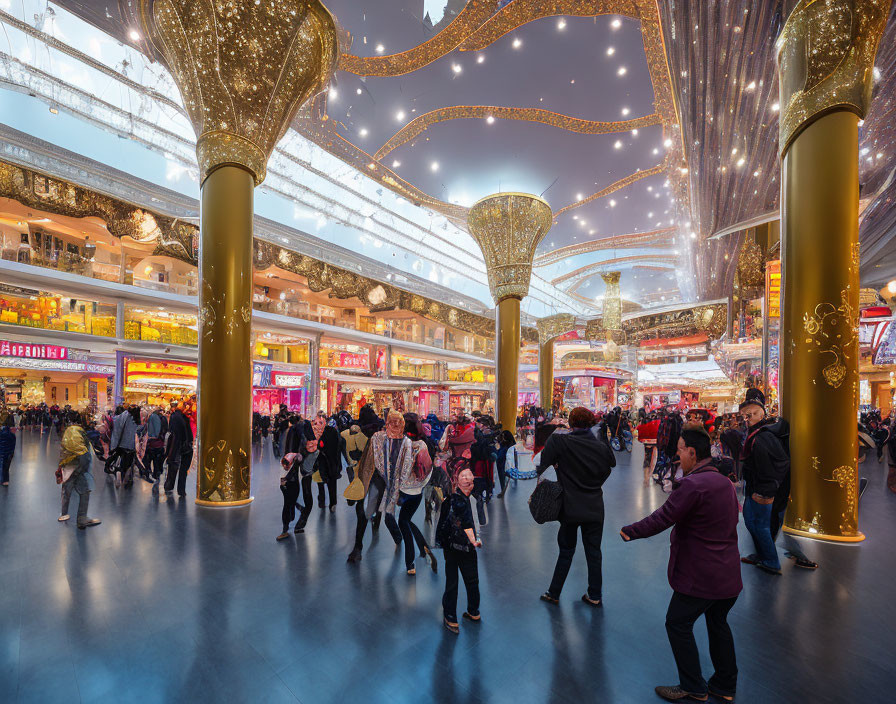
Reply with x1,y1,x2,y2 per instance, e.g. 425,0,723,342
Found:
0,432,896,704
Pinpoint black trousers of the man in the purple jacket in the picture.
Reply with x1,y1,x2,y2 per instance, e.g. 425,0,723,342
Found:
666,592,737,696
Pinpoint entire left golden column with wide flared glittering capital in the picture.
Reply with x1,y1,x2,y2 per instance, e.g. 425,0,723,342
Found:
140,0,338,506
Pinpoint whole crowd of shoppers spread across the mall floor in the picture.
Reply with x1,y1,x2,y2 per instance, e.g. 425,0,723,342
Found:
7,382,889,701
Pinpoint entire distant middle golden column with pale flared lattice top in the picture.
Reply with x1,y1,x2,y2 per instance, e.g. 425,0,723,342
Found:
467,193,553,432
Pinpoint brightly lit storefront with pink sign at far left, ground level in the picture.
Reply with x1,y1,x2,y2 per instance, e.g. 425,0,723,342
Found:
0,340,115,410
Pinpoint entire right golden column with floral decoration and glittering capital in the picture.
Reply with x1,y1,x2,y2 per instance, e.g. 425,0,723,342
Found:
778,0,890,542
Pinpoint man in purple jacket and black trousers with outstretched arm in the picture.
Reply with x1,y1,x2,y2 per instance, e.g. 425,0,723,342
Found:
620,426,743,702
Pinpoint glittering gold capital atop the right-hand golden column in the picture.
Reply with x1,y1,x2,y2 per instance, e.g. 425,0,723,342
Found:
777,0,890,154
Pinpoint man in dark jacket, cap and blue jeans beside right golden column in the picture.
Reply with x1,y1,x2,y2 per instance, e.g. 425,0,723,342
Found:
740,395,790,574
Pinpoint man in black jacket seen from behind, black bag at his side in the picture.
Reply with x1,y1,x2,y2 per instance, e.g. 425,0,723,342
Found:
536,406,616,606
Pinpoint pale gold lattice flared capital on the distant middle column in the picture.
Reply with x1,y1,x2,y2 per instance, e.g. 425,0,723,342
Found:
467,193,554,303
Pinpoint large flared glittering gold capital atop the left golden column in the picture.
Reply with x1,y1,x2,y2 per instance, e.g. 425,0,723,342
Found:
140,0,338,185
